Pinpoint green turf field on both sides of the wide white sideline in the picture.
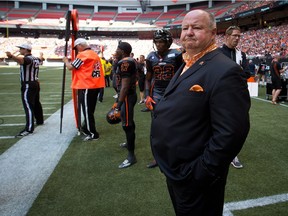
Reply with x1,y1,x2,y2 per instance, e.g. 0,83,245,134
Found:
0,67,288,216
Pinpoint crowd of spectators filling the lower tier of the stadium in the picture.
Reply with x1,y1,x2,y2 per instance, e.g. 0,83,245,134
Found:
0,24,288,58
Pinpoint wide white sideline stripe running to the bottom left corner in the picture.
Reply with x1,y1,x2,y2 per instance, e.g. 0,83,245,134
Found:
0,101,77,216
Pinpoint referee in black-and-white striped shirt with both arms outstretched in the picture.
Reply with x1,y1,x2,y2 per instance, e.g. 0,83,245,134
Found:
6,44,44,137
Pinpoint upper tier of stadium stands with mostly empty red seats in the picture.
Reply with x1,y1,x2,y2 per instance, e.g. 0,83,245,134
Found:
0,2,264,27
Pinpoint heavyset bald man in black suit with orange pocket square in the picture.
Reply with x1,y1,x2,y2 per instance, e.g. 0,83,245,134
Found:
151,10,250,216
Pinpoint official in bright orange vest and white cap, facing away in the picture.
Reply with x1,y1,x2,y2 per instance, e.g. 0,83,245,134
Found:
63,38,105,141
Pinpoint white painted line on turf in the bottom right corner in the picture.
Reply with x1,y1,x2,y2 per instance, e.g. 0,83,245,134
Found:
223,193,288,216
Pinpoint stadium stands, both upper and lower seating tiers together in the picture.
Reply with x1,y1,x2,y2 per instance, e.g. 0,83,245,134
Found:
0,0,288,59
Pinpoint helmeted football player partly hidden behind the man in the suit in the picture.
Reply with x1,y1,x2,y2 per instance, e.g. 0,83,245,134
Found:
145,29,183,168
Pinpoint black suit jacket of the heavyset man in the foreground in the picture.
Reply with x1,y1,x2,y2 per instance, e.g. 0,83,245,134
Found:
151,49,250,183
